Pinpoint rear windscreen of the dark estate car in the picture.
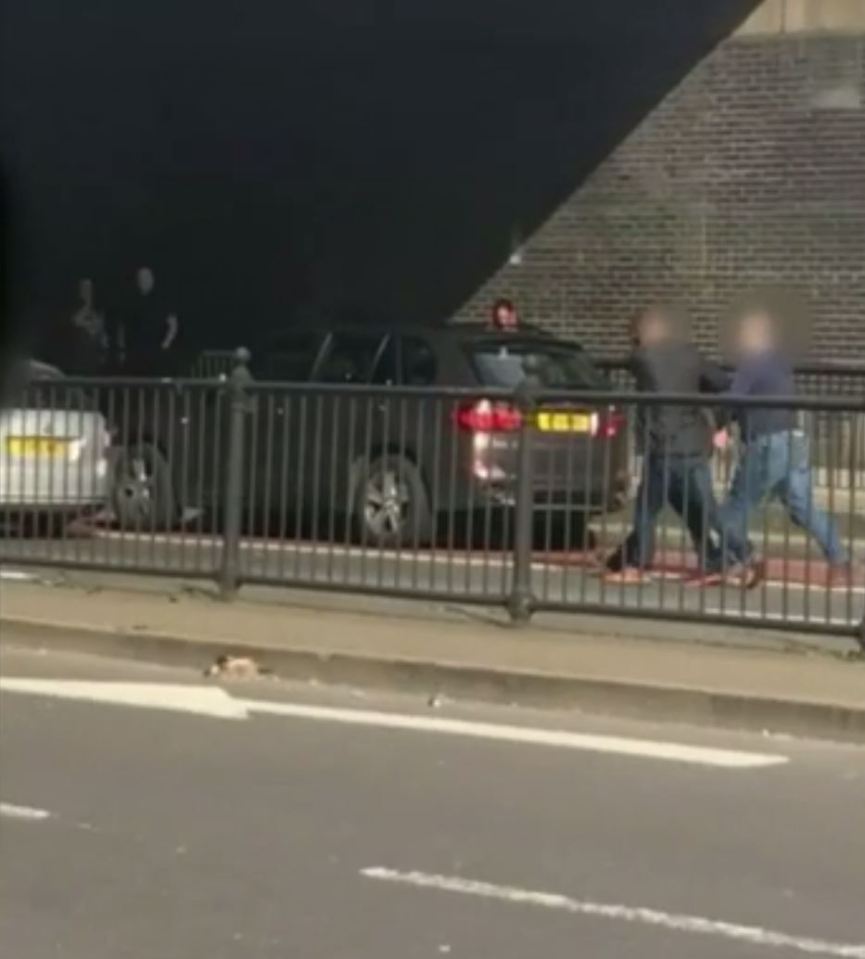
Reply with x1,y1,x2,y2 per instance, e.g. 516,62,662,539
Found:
469,341,609,390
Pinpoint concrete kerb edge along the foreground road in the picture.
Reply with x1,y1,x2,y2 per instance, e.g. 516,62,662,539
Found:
6,616,865,742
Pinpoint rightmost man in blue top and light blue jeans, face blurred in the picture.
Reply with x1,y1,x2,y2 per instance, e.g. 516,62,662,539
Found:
708,304,851,584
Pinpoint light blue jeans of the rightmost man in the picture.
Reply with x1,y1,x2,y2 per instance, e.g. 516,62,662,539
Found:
720,430,848,565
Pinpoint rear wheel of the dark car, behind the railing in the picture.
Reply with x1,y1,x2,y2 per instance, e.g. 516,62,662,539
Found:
354,454,432,549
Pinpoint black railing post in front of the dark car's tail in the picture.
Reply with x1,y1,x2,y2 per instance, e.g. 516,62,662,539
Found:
508,370,537,623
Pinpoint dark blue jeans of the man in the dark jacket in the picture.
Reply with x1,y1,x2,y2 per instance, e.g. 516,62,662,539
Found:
608,451,722,572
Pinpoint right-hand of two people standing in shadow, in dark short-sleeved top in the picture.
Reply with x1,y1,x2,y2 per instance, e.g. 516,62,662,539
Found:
118,266,180,376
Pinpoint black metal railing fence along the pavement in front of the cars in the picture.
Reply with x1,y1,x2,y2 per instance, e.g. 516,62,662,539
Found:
0,357,865,639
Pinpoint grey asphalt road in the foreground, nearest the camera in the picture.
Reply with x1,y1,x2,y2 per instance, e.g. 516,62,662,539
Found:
0,650,865,959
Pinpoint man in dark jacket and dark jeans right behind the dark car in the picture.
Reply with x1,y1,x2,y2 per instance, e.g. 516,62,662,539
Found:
607,306,728,584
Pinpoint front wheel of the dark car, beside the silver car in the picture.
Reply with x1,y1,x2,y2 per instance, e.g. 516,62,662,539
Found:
111,443,177,531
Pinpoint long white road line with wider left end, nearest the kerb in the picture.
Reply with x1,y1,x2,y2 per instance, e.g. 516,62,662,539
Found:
0,677,788,769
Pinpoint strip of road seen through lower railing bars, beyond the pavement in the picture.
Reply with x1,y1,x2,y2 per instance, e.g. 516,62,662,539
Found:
0,533,865,628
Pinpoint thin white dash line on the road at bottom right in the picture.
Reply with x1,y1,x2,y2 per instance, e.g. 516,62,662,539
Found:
361,867,865,959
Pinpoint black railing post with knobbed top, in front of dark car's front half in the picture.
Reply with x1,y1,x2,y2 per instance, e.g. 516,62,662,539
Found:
219,348,252,600
